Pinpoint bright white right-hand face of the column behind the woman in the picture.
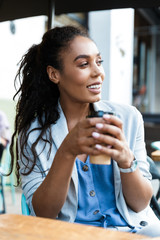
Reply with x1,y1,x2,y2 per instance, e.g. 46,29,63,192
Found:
109,9,134,104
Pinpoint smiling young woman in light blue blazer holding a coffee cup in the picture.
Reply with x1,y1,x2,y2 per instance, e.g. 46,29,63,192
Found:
11,26,160,236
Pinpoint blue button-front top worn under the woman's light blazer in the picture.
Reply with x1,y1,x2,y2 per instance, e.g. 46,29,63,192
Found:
75,157,134,228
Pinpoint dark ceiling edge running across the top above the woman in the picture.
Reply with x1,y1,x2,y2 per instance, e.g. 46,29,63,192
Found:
0,0,160,21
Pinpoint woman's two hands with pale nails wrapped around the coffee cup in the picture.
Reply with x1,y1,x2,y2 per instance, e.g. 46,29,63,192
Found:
72,115,130,163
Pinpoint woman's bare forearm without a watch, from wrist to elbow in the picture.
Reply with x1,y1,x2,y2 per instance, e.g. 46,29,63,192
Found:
32,144,75,218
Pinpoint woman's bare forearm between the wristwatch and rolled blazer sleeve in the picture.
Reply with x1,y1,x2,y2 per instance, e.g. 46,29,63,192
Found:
121,169,153,212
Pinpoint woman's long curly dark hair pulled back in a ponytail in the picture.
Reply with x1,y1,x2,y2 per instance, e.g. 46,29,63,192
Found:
10,26,88,185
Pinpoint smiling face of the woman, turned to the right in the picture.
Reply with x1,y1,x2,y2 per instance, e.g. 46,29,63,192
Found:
55,36,105,103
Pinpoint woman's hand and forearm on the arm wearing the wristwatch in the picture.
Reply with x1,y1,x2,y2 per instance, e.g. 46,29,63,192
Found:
91,110,152,212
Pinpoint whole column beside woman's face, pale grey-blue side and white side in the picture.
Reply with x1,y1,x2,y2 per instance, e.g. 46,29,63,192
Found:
89,9,134,104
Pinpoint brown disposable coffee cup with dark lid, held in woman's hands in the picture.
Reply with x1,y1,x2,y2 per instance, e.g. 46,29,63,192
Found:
87,111,115,165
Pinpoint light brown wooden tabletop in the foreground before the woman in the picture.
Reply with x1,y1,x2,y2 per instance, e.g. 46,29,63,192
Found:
0,214,160,240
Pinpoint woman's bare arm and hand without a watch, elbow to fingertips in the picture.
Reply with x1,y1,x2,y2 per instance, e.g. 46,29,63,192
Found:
22,119,102,218
